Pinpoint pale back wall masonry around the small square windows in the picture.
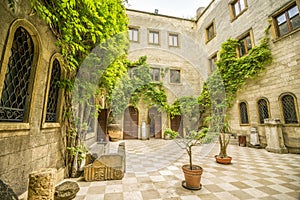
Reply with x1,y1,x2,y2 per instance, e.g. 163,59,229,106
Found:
127,10,206,138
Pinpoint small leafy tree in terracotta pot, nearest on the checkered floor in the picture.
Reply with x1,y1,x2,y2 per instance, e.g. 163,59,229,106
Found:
175,128,214,190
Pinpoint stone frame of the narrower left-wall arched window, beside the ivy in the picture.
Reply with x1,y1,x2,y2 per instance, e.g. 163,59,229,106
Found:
42,53,65,128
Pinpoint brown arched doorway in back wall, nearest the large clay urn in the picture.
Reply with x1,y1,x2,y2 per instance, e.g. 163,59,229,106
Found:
123,106,139,139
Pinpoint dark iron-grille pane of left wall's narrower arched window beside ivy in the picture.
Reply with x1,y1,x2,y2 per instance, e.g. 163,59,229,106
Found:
46,59,61,122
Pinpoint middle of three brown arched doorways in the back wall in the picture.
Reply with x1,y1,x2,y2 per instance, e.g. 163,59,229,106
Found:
148,107,161,138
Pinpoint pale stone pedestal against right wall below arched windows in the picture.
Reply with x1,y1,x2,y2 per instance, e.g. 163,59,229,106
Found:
265,119,288,153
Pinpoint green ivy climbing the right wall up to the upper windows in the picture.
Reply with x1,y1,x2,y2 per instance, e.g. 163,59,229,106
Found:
198,27,272,129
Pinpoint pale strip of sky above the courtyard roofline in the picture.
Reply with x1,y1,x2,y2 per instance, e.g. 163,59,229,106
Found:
126,0,211,18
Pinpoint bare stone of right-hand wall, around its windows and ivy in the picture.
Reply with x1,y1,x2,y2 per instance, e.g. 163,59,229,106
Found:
197,0,300,152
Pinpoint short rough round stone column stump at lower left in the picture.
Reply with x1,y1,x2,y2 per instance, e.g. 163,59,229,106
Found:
28,168,56,200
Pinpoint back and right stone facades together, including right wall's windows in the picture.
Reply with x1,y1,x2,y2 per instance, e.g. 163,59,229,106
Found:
127,0,300,153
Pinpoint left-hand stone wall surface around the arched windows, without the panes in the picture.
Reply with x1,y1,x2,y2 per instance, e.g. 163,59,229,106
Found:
0,1,64,195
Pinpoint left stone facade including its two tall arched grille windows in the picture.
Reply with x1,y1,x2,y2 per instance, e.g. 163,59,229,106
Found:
0,1,65,195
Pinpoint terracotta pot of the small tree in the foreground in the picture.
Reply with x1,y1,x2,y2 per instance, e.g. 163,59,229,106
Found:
182,165,203,190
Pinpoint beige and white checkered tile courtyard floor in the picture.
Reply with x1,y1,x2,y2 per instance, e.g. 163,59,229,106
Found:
75,139,300,200
